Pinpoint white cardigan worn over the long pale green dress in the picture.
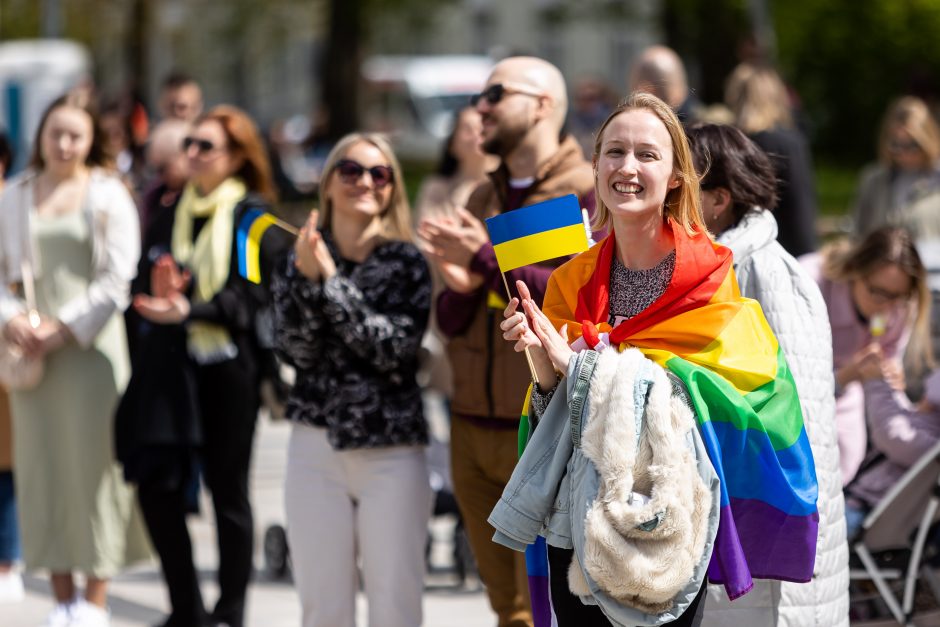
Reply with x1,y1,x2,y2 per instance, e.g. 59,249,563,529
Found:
0,168,140,348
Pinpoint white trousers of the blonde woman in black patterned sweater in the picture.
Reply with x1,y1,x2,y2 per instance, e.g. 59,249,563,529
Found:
284,424,431,627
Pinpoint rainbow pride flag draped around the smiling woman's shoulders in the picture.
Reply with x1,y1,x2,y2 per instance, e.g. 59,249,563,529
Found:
543,220,819,599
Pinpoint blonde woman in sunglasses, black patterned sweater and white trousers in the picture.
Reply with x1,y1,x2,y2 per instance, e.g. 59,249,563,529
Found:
274,133,431,627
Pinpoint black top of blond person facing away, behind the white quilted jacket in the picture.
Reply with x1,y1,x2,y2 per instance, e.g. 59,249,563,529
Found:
751,128,818,257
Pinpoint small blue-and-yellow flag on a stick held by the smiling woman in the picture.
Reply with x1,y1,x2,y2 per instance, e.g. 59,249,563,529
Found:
486,194,588,272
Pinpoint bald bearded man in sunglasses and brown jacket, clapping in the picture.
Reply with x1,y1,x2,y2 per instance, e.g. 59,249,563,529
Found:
419,57,594,627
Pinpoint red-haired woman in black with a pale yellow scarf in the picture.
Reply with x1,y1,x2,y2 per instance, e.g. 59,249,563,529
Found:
131,106,275,627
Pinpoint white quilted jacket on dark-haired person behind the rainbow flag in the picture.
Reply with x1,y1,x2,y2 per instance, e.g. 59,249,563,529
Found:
702,210,849,627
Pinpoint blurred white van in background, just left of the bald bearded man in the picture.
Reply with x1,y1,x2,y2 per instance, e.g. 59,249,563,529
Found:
362,55,493,161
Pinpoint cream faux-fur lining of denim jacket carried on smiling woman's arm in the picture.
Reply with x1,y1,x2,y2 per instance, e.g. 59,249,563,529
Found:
568,349,714,614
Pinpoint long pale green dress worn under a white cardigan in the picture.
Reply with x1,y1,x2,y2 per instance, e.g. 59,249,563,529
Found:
11,211,149,579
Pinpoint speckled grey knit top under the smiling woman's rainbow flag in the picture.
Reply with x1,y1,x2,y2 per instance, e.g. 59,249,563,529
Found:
529,251,676,423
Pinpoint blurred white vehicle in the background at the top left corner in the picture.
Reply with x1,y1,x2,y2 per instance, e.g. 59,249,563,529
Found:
0,39,91,171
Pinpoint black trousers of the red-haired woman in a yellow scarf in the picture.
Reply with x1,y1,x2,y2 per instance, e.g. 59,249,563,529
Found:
138,359,260,627
